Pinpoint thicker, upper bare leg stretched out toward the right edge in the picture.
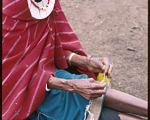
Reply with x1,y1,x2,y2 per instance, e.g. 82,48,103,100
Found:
104,88,148,116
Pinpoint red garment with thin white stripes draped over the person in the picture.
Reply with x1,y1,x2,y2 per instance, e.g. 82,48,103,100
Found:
2,0,95,120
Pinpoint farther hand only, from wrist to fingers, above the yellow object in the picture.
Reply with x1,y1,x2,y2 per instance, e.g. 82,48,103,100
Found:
87,57,113,77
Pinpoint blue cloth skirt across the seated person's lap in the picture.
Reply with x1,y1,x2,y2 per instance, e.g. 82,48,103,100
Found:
29,69,120,120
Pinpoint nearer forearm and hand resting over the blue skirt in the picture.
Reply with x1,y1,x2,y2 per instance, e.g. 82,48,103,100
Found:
47,77,106,100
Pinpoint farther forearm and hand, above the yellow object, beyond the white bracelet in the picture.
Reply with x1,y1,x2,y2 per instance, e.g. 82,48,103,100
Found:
68,54,113,77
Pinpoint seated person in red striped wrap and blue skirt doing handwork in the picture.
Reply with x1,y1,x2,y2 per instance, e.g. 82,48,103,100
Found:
2,0,148,120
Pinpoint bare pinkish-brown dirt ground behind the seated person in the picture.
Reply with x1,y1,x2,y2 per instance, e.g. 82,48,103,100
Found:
61,0,148,100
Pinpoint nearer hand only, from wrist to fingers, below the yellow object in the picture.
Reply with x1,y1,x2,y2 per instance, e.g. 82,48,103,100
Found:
69,78,106,100
